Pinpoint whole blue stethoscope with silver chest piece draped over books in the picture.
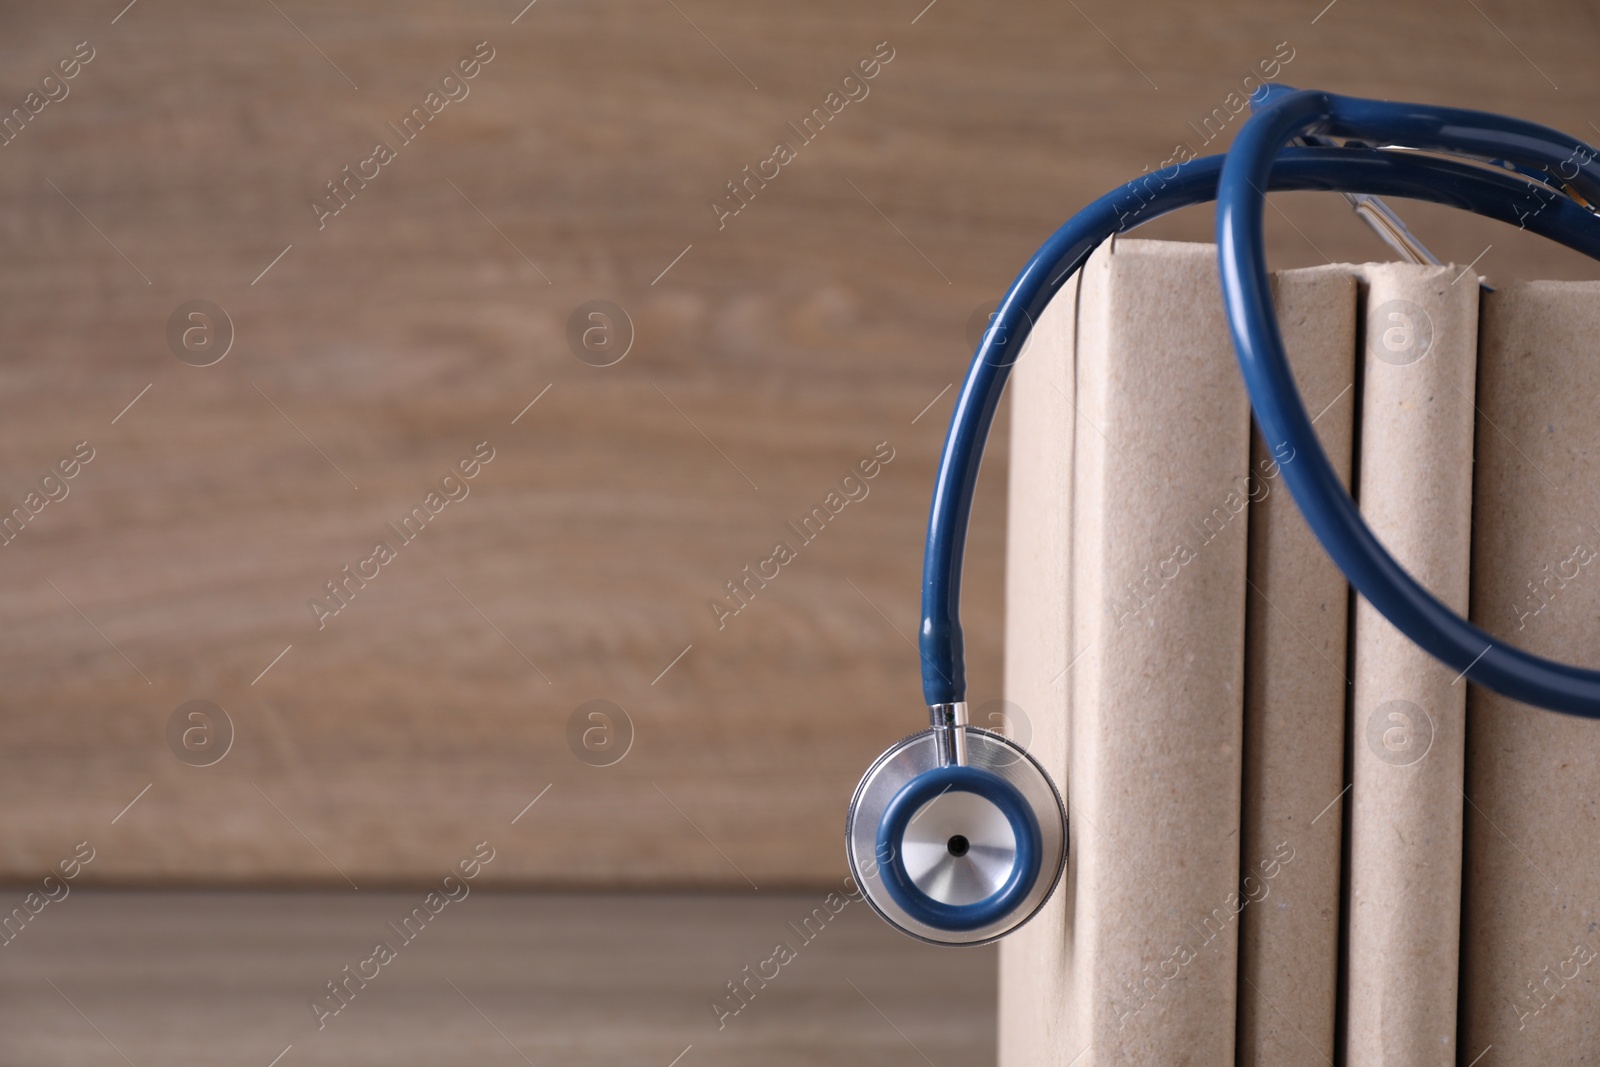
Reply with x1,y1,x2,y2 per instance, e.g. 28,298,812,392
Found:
845,85,1600,944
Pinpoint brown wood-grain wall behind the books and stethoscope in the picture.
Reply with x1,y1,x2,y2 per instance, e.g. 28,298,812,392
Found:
0,0,1600,888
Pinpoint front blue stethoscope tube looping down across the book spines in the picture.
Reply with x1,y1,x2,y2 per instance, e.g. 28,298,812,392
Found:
1216,91,1600,718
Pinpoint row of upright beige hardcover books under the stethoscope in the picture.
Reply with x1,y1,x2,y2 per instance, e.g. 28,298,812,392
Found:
1000,240,1600,1067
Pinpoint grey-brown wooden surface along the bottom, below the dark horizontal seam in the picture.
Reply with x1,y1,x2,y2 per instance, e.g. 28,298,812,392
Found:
0,891,995,1067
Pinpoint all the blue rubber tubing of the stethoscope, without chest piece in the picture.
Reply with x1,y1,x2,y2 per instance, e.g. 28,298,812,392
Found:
918,106,1600,717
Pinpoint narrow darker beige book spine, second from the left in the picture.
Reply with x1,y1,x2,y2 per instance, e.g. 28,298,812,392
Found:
1238,267,1357,1067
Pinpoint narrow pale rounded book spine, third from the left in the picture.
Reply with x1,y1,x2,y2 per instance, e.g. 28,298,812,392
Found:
1344,264,1478,1067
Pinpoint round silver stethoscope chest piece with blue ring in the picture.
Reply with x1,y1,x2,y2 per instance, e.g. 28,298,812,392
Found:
845,728,1067,945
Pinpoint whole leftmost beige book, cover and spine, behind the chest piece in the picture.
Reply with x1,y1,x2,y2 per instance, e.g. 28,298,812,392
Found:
1000,240,1354,1067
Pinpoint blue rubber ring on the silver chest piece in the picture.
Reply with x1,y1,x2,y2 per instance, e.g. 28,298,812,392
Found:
877,766,1045,931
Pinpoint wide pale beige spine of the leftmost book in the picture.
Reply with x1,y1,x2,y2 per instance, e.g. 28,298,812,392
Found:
1058,240,1250,1065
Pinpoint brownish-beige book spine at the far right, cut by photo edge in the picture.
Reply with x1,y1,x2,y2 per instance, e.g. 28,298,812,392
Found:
1461,282,1600,1067
